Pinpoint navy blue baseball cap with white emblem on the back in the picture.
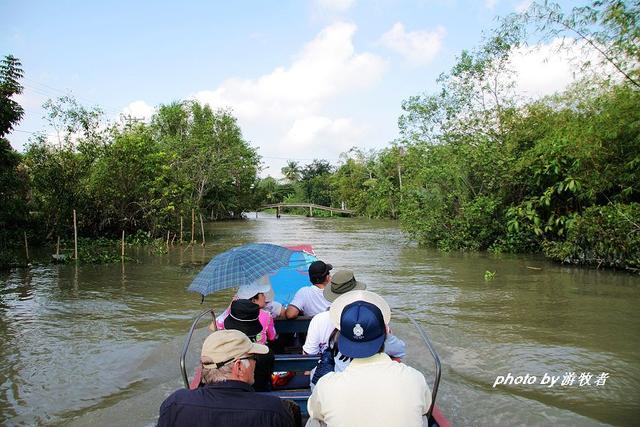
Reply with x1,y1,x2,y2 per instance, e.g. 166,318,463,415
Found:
338,301,386,358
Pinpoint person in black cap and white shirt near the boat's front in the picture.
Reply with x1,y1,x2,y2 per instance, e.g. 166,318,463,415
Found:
285,261,333,319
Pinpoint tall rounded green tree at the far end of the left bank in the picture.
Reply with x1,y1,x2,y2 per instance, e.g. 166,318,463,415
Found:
152,102,260,218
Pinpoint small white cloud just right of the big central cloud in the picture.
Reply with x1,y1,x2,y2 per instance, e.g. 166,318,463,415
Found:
380,22,446,65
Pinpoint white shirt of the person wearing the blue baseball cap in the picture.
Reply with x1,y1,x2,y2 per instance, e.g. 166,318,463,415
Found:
308,353,431,427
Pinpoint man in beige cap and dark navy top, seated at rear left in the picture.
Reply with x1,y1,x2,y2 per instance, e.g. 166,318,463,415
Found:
157,330,294,427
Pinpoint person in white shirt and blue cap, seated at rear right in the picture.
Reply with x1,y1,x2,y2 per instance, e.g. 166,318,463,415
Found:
307,291,431,427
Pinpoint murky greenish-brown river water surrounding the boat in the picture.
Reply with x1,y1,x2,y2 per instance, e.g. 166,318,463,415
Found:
0,214,640,427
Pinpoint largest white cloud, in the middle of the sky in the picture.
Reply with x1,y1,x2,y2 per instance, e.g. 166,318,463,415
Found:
193,23,386,119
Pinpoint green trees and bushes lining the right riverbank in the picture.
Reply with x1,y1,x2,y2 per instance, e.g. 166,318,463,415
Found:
256,0,640,271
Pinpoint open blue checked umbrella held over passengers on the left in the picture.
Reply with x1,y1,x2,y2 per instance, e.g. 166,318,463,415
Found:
188,243,296,297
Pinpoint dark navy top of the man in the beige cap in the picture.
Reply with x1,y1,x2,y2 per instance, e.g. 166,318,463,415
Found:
158,381,293,427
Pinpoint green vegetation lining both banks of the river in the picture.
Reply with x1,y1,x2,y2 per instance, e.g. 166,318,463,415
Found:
0,0,640,272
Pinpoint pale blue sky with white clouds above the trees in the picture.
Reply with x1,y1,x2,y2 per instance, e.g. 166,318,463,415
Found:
0,0,575,177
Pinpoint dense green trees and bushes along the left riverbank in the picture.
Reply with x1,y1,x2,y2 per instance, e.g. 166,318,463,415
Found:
0,71,260,259
